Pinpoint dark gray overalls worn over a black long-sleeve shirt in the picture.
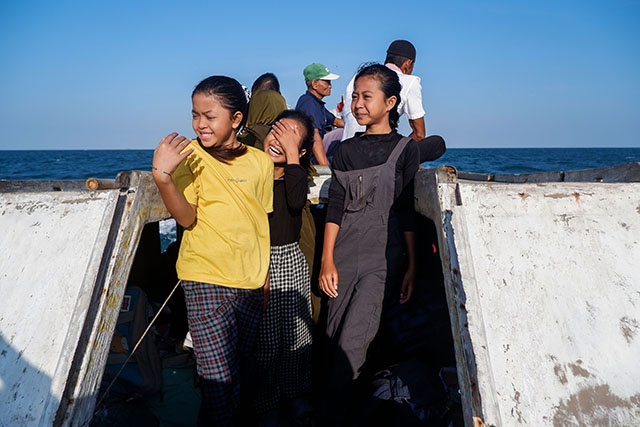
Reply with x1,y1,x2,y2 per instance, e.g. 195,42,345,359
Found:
327,137,410,414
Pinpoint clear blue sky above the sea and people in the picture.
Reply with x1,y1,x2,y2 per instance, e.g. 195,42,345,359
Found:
0,0,640,149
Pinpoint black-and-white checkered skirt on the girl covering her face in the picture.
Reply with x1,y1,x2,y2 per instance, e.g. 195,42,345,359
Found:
255,243,312,414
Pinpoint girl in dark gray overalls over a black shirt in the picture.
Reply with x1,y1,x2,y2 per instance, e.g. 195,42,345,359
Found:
319,64,419,419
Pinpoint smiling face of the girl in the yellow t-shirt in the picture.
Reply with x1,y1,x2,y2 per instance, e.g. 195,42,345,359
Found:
191,93,242,147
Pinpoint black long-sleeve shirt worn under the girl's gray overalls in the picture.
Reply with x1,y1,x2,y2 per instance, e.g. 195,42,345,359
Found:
326,131,420,231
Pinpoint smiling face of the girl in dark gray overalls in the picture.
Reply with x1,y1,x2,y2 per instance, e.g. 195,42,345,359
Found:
351,76,397,130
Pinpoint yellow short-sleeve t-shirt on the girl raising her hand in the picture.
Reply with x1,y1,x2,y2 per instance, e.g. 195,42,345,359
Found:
173,140,273,289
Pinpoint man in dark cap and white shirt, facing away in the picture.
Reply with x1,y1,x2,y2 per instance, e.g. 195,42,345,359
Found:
342,40,426,141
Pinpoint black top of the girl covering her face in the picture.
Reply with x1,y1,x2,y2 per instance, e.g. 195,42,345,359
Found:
269,165,309,246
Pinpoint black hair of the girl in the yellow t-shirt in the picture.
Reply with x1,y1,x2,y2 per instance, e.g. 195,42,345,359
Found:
191,76,248,163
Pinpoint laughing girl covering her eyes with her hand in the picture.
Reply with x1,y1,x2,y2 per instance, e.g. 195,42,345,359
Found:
255,110,313,422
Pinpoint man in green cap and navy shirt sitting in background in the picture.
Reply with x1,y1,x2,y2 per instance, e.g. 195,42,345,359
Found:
296,62,344,165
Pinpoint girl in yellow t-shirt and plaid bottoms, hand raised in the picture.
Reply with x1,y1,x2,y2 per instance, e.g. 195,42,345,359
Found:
153,76,273,425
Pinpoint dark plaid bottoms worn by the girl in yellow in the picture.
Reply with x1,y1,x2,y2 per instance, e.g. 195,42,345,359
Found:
182,280,264,425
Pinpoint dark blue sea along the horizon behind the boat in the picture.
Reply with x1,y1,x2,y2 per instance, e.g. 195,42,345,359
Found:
0,147,640,180
